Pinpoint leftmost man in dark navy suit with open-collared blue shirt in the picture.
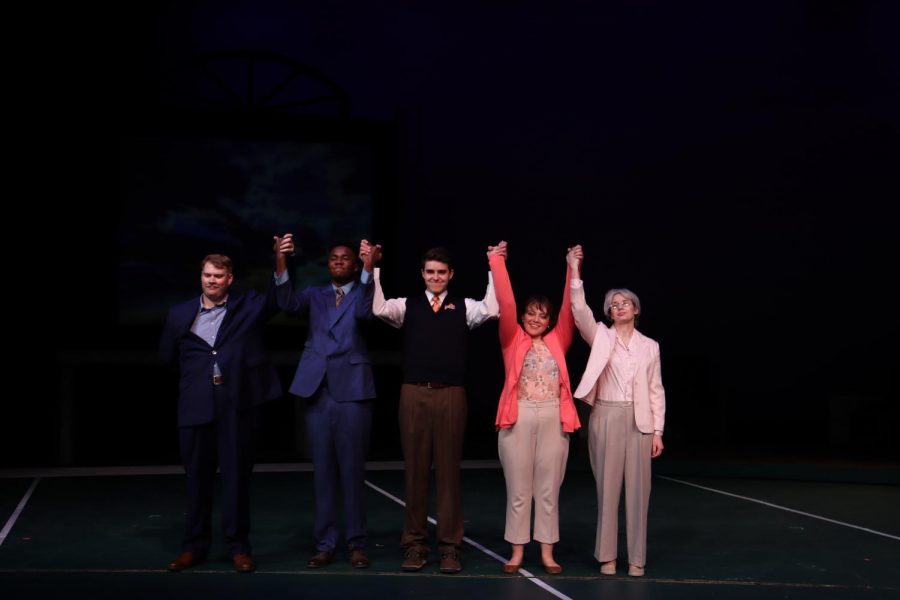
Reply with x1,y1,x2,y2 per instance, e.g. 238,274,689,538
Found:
160,248,281,573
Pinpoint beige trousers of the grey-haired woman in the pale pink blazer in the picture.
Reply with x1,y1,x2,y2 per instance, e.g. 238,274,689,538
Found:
588,400,653,567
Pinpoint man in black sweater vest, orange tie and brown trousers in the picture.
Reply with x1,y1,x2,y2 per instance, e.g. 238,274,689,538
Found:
368,241,500,573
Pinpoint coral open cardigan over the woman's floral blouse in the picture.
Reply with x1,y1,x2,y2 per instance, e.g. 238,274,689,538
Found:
489,254,581,433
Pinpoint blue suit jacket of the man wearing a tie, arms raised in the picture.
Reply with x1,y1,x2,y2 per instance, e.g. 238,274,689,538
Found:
276,279,375,402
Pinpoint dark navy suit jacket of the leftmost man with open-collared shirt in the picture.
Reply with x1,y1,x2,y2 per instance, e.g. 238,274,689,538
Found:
159,283,282,427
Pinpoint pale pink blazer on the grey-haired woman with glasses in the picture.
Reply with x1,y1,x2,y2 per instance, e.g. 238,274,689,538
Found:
571,279,666,433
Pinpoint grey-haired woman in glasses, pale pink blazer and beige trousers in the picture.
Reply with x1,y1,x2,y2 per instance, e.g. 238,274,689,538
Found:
567,246,666,577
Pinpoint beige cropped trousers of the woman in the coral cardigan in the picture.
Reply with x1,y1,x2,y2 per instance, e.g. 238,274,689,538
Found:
497,400,569,544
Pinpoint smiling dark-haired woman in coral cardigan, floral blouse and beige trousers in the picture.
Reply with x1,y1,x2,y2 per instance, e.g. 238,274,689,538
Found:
488,242,581,575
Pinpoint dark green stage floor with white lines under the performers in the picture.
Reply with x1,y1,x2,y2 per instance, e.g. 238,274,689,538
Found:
0,467,900,600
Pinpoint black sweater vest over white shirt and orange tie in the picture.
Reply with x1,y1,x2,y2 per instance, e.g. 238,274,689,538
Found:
403,293,469,385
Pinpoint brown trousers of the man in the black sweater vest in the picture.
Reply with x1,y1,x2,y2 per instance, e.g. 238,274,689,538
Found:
400,383,467,550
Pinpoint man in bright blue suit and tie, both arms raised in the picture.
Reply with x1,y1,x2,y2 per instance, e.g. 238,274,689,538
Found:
275,234,375,569
